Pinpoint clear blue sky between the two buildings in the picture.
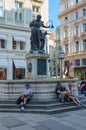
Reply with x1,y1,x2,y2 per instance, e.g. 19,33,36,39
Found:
49,0,60,33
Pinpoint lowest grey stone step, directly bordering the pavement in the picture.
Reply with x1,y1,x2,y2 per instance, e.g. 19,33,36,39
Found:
0,104,86,114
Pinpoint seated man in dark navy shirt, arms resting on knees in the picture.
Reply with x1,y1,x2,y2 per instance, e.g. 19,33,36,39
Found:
56,82,70,102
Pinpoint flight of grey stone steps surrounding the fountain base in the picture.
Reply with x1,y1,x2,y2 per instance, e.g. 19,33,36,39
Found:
0,96,86,114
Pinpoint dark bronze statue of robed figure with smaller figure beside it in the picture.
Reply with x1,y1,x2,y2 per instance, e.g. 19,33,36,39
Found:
30,15,50,51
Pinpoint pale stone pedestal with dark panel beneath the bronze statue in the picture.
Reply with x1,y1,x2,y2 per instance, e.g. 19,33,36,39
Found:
26,51,49,79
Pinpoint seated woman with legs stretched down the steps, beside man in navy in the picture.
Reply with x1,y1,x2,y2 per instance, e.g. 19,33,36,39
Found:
68,82,83,106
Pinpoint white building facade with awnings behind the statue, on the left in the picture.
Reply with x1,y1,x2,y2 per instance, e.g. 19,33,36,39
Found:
0,0,48,80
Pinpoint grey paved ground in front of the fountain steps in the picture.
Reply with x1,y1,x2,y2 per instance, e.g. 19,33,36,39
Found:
0,109,86,130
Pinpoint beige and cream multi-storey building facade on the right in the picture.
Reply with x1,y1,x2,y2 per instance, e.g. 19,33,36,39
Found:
58,0,86,79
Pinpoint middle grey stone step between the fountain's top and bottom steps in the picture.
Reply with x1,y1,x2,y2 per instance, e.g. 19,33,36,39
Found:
0,99,86,109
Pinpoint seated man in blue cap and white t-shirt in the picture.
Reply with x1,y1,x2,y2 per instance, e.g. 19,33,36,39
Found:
20,82,33,110
